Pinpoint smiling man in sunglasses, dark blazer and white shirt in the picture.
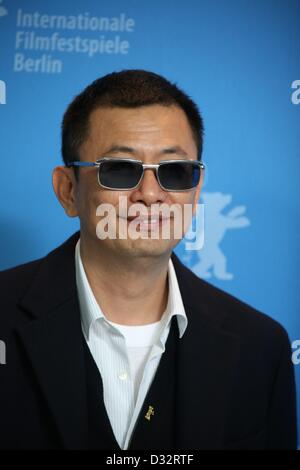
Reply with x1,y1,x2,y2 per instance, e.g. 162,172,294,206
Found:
0,70,297,450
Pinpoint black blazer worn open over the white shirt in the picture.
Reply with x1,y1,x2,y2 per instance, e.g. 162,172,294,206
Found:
0,233,297,450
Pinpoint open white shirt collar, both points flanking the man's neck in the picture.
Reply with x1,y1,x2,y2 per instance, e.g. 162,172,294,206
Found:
75,239,188,339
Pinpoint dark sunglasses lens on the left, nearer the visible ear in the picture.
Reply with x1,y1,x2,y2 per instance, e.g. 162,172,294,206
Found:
99,160,143,190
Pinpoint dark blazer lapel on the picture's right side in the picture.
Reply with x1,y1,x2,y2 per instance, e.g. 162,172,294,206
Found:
172,255,240,449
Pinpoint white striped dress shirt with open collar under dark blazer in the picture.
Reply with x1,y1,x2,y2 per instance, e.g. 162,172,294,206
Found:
75,240,187,450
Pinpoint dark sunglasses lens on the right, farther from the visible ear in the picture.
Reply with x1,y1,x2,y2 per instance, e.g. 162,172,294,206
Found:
158,161,201,191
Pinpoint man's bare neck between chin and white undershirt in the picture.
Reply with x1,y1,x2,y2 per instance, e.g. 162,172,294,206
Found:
80,240,169,325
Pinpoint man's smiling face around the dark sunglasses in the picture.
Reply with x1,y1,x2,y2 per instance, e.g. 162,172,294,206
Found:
70,105,202,257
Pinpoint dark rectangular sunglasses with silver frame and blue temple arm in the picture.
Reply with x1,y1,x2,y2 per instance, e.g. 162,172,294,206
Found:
66,157,205,191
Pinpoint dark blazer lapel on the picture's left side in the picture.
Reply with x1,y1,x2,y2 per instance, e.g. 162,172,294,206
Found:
17,234,87,449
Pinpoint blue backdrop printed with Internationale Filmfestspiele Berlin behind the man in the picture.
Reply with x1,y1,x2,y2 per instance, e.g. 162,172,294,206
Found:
0,0,300,444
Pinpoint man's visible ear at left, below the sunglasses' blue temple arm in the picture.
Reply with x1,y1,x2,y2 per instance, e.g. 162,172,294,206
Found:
52,166,78,217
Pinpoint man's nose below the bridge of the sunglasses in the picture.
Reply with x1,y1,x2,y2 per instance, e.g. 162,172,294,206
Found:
130,168,167,206
